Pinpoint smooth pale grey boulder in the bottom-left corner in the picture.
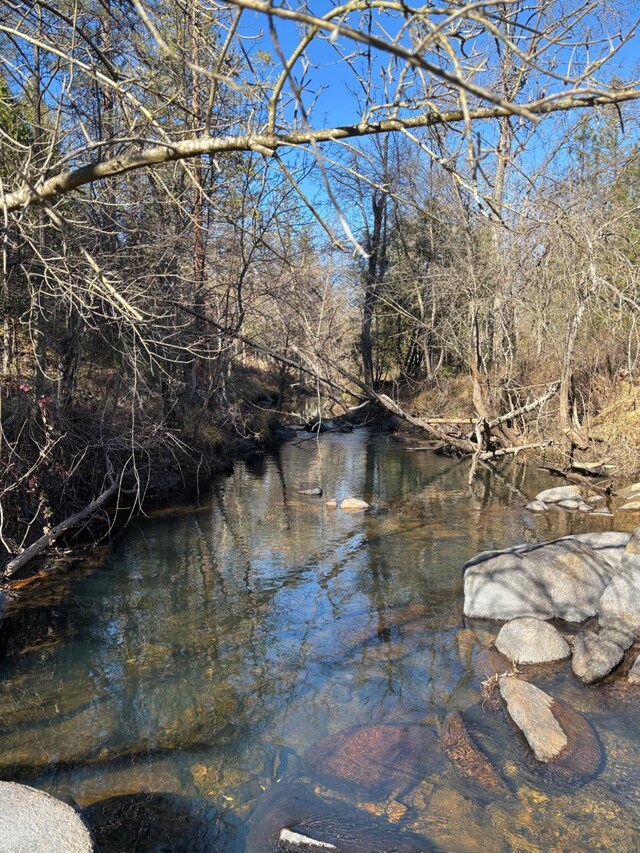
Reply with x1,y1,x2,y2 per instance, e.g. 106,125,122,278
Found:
0,782,93,853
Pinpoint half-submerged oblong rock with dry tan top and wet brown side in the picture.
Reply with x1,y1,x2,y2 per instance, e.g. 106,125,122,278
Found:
500,676,603,784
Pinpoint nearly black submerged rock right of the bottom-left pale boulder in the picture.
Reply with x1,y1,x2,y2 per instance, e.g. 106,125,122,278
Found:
80,794,231,853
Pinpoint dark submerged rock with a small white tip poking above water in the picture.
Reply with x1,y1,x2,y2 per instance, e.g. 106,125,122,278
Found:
246,782,434,853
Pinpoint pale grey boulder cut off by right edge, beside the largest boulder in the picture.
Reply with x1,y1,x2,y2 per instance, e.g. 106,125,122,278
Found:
598,527,640,637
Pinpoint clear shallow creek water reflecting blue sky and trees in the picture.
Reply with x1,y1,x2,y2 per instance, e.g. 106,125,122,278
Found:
0,431,640,853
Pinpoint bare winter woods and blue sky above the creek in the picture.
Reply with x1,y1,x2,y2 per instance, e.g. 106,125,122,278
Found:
0,0,640,576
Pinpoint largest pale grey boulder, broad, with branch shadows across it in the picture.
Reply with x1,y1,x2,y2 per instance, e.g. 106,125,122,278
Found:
463,537,613,622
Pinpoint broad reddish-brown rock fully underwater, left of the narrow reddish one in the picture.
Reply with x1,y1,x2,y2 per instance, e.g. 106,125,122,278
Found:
305,724,442,801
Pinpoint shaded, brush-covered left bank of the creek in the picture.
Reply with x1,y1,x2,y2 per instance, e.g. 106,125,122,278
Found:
0,370,286,589
